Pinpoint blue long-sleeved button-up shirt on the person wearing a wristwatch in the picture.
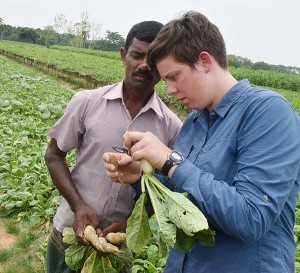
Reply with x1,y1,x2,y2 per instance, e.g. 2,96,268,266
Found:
160,80,300,273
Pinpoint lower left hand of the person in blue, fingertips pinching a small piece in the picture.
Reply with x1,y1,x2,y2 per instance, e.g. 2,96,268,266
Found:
102,153,141,184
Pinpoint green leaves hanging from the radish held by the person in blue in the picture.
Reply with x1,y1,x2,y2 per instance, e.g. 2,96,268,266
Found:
126,174,214,253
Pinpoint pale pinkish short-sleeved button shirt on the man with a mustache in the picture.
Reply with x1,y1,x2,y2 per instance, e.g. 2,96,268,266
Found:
48,82,182,232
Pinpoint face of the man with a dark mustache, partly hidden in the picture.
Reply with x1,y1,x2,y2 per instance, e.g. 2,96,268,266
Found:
121,38,160,92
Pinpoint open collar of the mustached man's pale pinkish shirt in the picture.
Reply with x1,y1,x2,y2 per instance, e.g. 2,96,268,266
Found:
103,82,164,118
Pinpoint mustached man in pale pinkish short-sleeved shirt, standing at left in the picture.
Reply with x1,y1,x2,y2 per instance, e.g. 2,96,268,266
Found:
45,21,182,273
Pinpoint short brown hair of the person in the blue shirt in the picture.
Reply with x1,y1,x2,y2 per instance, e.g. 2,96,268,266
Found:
147,11,228,68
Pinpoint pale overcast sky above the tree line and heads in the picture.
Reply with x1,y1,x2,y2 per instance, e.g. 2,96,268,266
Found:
0,0,300,67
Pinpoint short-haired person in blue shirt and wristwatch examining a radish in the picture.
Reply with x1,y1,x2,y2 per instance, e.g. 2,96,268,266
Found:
103,12,300,273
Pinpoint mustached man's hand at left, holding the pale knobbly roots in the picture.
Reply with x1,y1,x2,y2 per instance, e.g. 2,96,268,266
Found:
73,204,102,245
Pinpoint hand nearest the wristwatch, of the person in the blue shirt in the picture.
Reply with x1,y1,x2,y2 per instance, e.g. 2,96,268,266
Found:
124,131,171,170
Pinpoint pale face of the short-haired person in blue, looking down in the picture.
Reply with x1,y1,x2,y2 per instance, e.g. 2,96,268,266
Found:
156,55,212,110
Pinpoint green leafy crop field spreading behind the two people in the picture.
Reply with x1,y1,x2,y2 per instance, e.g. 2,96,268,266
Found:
0,41,300,273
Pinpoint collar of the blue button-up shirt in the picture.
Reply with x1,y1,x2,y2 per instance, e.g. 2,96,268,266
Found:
194,79,250,119
